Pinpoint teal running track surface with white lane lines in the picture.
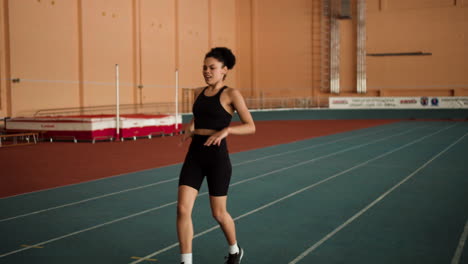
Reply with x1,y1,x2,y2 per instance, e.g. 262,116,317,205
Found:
0,121,468,264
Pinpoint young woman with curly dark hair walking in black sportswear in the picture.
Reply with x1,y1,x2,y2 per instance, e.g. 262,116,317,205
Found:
177,48,255,264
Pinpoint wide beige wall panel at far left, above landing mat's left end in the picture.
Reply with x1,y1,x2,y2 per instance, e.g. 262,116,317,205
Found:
8,0,79,116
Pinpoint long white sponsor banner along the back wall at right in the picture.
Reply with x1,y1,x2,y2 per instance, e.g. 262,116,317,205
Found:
328,96,468,109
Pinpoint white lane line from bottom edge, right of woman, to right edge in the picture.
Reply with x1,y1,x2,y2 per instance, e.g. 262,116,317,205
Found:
289,133,468,264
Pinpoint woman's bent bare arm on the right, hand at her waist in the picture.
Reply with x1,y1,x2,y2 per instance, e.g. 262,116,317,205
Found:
205,89,255,146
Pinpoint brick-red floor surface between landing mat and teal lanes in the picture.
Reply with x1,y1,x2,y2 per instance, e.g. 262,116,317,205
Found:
0,120,395,198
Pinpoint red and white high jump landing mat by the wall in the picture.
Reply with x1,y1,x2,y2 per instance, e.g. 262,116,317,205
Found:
5,114,182,142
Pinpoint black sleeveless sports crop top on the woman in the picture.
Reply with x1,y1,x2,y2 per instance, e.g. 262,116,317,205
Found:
192,86,232,131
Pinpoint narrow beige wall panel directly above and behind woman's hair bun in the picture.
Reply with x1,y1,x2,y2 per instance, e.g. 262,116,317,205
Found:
210,0,239,87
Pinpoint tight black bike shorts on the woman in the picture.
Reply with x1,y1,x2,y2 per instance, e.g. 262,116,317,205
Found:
179,135,232,196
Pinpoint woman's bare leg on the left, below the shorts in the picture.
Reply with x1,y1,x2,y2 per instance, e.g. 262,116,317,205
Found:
177,185,198,254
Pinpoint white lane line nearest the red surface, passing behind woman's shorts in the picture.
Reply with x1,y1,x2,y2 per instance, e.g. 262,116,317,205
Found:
0,124,402,223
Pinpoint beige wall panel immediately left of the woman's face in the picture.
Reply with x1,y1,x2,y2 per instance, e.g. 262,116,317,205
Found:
178,0,209,88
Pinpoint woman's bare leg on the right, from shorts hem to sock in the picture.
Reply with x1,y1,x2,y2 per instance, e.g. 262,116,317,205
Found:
210,196,236,245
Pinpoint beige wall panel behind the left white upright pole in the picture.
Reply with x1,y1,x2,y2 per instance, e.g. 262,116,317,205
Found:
82,0,136,106
